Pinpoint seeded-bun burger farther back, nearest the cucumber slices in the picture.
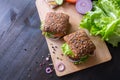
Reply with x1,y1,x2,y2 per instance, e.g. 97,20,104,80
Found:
41,12,69,38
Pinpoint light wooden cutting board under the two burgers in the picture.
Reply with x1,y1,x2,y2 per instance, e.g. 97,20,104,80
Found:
36,0,112,76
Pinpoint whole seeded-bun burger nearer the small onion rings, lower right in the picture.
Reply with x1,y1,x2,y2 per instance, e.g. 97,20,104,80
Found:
62,30,96,64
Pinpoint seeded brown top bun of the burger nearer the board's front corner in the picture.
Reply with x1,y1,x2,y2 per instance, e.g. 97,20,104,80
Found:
64,30,96,60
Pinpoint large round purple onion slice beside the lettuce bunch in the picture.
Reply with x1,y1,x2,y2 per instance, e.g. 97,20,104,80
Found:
75,0,92,14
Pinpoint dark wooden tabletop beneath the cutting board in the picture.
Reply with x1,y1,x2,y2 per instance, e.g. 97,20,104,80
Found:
0,0,120,80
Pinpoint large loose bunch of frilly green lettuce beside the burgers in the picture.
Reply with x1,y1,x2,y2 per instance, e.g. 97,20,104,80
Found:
80,0,120,46
